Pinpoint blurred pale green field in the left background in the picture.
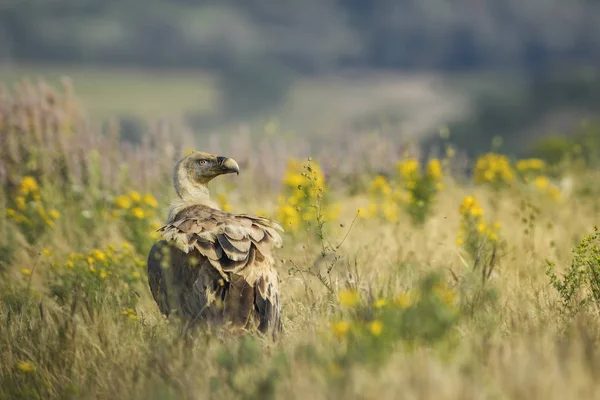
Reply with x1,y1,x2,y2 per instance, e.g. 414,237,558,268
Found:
0,65,217,119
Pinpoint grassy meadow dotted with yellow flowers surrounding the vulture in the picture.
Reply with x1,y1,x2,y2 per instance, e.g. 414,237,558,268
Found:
0,78,600,399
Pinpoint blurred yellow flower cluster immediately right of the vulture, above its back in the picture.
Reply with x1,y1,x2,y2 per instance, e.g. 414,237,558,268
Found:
276,159,339,232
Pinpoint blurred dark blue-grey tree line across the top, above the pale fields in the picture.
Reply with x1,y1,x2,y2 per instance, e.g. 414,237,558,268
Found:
0,0,600,72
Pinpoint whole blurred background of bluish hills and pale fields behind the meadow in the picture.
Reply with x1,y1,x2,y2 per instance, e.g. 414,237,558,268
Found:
0,0,600,158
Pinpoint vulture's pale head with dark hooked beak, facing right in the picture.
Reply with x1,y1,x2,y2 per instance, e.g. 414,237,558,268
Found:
174,151,240,198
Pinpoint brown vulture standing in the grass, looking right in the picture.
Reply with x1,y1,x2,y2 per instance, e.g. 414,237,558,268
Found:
148,151,283,338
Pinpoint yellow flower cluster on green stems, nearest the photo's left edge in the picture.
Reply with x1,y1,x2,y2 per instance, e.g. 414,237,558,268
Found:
6,176,60,243
